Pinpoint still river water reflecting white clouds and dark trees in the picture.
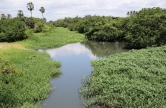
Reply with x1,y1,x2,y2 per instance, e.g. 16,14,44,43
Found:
39,41,127,108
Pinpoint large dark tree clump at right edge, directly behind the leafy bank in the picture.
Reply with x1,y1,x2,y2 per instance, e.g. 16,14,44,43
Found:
124,15,166,48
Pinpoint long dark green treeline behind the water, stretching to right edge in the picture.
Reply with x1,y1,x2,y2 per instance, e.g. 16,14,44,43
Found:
53,7,166,48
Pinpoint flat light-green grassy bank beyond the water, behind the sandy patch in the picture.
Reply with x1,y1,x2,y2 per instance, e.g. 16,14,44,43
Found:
17,27,85,49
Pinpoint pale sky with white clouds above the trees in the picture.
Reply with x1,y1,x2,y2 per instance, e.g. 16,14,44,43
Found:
0,0,166,21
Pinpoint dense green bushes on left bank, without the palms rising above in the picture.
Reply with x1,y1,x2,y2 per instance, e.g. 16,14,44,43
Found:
0,17,54,42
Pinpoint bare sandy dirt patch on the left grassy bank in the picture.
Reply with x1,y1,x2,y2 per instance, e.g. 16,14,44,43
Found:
0,43,25,49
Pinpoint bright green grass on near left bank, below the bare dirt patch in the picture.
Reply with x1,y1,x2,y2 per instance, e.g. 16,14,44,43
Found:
0,49,61,108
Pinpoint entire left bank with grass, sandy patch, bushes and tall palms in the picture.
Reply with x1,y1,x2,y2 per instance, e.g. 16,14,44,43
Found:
0,2,85,108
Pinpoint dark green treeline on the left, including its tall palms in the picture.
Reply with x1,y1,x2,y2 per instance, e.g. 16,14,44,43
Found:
0,2,54,42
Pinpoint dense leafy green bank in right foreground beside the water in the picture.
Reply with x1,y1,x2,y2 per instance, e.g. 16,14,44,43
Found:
80,46,166,108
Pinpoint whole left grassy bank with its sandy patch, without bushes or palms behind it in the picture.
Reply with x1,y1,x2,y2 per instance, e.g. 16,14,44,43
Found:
0,28,84,108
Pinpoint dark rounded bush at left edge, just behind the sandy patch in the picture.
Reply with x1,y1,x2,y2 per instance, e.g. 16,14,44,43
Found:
0,19,28,42
